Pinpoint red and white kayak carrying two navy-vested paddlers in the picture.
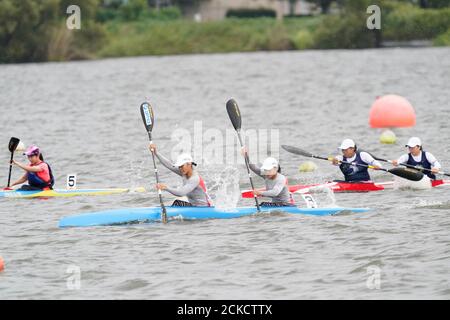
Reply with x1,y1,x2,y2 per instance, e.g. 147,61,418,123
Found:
242,180,450,198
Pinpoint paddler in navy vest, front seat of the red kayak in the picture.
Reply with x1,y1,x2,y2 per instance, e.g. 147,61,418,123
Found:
333,139,382,182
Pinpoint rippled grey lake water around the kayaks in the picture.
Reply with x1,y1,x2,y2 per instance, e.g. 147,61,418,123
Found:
0,48,450,299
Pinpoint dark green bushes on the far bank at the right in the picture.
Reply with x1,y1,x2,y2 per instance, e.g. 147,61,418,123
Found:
314,0,450,49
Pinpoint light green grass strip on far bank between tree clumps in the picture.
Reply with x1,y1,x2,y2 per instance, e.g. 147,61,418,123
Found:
99,18,319,57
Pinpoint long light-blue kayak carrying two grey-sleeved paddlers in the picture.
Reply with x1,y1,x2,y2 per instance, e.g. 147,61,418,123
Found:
59,207,370,228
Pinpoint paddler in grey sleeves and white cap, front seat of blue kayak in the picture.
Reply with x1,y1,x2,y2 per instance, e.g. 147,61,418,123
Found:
149,144,212,207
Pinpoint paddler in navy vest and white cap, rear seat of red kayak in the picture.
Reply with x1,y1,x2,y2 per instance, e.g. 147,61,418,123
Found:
392,137,441,180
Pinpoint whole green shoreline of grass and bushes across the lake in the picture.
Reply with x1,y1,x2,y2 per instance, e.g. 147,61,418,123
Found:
0,2,450,63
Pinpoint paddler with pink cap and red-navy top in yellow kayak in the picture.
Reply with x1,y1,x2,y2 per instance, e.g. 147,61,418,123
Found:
7,146,55,190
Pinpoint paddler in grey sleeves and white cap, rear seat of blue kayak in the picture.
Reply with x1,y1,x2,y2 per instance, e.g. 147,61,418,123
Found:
242,148,294,207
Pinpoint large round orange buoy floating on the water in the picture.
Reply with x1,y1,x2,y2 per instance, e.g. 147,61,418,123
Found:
369,94,416,128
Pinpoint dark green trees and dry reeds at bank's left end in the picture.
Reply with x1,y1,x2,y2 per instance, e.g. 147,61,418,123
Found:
0,0,106,63
